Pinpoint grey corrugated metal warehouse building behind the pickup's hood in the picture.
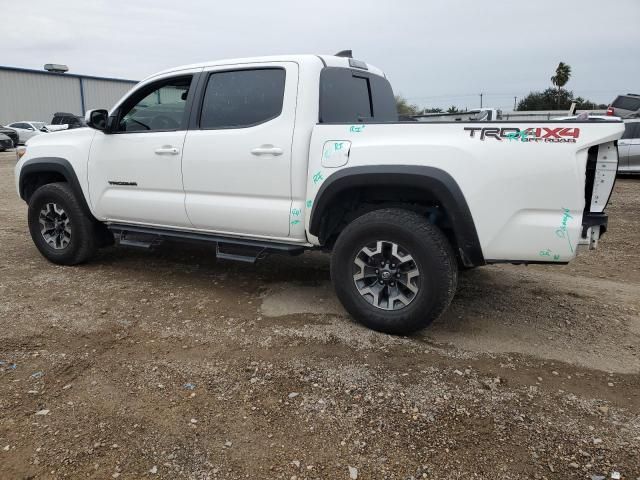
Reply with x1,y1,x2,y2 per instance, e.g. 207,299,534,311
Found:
0,66,137,125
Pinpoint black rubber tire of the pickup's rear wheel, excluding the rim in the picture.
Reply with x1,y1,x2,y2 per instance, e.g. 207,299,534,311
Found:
331,208,458,335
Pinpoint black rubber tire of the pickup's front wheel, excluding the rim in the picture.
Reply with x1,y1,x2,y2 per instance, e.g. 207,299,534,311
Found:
28,183,98,265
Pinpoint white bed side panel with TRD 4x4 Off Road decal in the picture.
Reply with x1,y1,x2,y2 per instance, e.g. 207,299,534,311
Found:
306,122,623,262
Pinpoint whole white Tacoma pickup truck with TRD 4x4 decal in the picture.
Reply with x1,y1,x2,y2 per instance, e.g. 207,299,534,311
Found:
15,54,624,334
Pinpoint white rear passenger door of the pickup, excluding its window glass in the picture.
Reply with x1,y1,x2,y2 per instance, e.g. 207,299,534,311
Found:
182,62,298,238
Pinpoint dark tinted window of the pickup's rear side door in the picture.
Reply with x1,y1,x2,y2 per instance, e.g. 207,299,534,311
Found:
200,68,286,129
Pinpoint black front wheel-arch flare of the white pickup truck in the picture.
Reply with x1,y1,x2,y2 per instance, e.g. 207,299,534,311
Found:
18,157,93,218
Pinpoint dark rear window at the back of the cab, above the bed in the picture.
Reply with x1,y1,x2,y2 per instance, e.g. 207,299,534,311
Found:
319,67,398,123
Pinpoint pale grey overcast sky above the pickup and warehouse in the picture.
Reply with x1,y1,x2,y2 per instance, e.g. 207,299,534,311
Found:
0,0,640,109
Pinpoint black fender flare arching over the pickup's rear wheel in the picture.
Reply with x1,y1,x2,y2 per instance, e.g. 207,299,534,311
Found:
309,165,485,266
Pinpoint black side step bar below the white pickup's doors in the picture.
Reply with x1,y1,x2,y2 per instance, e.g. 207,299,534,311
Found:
107,223,305,263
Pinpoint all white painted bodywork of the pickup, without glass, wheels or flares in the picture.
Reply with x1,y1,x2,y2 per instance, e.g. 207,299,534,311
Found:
16,55,624,261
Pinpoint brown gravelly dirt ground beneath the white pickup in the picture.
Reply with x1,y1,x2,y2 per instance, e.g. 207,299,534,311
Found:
0,152,640,480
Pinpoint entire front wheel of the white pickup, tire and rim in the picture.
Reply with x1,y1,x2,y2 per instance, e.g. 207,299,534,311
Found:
28,183,97,265
